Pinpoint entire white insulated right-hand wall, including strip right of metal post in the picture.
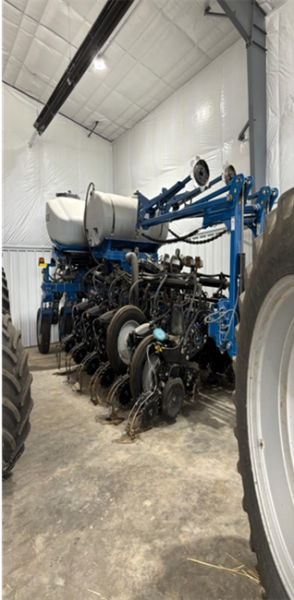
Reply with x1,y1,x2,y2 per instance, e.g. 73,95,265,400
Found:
113,0,294,272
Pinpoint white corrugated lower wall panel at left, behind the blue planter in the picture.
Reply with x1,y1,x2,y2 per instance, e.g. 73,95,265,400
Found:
1,248,58,346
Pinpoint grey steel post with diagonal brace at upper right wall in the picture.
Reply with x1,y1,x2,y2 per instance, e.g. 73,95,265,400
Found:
217,0,267,189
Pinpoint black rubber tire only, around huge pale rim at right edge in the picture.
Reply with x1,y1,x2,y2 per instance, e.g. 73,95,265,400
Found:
235,188,294,600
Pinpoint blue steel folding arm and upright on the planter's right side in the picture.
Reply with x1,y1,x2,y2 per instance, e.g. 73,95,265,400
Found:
137,174,278,358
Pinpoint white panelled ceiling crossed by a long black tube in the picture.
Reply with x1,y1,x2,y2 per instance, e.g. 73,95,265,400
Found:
1,0,284,140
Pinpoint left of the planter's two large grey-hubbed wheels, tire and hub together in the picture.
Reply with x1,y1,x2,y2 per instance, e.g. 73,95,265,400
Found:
106,305,146,375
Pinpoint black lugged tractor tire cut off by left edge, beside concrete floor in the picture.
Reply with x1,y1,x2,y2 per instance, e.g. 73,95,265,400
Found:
0,315,33,477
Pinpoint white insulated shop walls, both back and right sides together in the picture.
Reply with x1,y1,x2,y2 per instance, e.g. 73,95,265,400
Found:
1,0,294,345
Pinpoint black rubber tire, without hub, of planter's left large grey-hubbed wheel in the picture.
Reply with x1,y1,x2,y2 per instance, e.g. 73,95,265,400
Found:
106,304,146,375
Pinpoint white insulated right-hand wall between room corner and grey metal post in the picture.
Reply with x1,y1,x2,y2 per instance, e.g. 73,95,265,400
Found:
113,40,251,273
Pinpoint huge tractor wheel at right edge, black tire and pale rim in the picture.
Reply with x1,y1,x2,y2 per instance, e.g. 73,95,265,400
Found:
236,188,294,600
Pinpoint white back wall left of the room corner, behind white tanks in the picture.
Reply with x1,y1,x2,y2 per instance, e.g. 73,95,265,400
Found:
1,84,113,346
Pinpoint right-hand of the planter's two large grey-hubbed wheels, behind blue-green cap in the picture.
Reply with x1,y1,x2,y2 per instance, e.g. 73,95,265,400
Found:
130,335,161,400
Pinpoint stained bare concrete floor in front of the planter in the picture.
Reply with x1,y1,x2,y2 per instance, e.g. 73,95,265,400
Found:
2,349,261,600
